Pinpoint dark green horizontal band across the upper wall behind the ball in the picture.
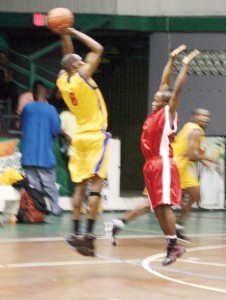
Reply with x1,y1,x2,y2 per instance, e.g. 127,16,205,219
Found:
0,13,225,32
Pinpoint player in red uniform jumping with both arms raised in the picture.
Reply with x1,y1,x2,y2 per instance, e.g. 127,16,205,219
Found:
141,45,199,266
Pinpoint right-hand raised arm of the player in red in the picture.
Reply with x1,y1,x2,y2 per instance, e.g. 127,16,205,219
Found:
169,49,199,124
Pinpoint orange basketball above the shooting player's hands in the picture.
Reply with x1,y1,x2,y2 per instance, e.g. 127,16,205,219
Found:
47,7,74,33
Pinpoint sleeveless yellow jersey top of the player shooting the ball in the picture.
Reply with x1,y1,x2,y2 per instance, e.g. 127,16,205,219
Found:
56,72,108,133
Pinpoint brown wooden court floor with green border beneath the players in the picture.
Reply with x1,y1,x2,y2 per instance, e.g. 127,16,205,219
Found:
0,211,226,300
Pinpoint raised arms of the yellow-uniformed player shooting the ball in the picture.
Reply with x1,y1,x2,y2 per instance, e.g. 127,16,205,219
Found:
59,28,104,78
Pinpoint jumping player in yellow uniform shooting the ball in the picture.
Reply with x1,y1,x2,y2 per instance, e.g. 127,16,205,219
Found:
56,28,110,256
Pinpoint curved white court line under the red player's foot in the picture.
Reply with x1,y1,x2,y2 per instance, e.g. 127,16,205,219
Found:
141,245,226,294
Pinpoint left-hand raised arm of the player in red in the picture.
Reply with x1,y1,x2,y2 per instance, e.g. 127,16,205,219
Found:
159,45,186,91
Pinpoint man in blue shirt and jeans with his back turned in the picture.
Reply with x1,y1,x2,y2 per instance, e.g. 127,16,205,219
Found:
20,81,62,216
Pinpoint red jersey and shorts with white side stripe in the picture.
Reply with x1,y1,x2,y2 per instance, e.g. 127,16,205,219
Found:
141,105,181,209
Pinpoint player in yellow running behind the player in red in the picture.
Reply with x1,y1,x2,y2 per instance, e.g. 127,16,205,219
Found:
172,108,216,241
